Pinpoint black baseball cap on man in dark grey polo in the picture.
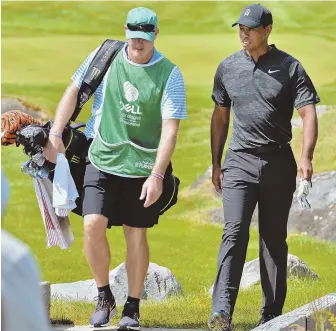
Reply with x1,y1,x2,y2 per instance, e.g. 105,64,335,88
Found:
232,4,273,29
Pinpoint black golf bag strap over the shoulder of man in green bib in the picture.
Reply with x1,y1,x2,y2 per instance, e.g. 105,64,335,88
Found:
70,39,125,122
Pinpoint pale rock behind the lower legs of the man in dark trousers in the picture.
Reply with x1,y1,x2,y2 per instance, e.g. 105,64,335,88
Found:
209,254,318,294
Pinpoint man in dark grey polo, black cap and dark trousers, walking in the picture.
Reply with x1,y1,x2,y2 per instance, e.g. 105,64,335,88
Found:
208,4,319,331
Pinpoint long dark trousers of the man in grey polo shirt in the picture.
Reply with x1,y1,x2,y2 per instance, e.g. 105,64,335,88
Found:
212,145,297,315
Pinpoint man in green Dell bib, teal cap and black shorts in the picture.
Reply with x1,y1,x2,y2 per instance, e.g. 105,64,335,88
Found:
44,7,186,330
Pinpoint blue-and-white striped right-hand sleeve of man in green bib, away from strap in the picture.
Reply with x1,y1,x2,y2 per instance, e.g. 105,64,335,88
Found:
161,67,187,119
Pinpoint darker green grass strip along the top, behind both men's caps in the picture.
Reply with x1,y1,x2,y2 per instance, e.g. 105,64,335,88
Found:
2,1,336,39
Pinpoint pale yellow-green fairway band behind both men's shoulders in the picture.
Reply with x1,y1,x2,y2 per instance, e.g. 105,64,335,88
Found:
2,32,336,87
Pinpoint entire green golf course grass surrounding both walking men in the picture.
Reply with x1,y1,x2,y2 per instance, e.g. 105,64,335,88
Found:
1,1,336,331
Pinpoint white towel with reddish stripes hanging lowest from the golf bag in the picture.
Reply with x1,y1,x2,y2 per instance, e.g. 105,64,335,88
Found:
33,178,74,249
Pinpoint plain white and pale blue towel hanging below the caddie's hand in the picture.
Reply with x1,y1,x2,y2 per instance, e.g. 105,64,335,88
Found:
52,153,78,217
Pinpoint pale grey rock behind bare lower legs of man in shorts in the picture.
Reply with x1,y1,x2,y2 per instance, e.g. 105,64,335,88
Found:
51,263,183,305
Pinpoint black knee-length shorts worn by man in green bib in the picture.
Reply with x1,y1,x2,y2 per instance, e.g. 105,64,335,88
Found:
83,164,179,228
